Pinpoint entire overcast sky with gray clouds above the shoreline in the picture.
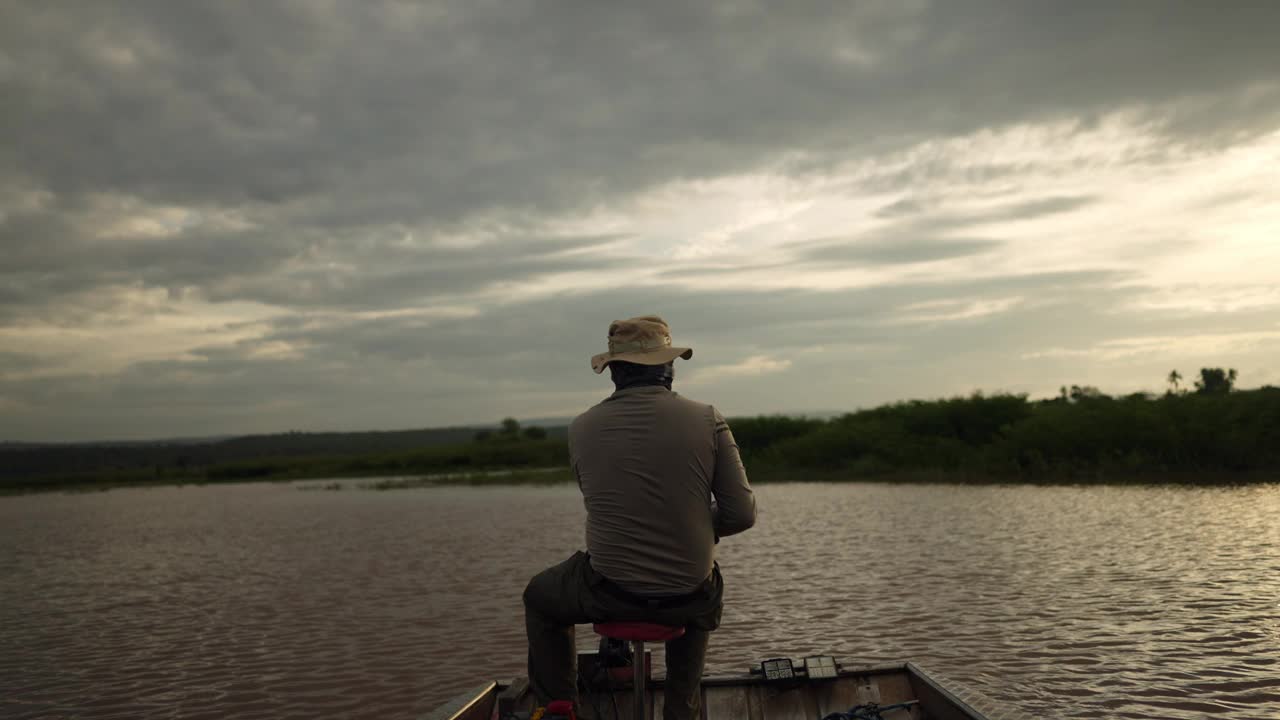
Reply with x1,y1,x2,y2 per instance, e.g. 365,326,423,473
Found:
0,0,1280,441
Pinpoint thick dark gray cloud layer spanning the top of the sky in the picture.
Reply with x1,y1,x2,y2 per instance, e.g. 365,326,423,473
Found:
3,3,1280,215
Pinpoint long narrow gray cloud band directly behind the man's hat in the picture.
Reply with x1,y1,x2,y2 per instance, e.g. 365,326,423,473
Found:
152,270,1139,388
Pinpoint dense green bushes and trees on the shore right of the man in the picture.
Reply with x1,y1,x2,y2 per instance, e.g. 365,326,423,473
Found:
732,368,1280,480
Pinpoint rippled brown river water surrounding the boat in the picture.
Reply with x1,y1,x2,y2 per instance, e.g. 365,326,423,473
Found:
0,483,1280,720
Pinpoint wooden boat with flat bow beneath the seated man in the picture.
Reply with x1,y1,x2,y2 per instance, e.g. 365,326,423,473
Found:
424,653,1021,720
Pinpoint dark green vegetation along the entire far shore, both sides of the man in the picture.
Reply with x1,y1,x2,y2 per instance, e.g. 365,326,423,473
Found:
0,368,1280,493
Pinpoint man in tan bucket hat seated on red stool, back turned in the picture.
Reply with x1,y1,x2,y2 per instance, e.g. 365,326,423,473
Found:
525,315,755,720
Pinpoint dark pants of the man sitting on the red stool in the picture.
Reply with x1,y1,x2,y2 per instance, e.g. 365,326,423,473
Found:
525,552,724,720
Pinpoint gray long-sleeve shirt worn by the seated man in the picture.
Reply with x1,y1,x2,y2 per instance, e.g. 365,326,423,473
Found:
568,387,755,596
